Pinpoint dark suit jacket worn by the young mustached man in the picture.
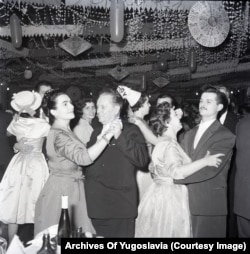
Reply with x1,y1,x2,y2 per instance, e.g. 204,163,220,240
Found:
175,120,235,216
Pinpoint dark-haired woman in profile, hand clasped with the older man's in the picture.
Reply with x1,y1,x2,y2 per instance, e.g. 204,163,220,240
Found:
35,89,122,234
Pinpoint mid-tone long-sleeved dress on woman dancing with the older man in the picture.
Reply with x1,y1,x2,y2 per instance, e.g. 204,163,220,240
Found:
35,128,95,234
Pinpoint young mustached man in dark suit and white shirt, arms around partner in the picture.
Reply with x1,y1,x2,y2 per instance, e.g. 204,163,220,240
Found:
176,87,235,237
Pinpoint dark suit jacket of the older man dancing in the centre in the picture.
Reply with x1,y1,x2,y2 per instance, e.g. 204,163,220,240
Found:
85,122,149,219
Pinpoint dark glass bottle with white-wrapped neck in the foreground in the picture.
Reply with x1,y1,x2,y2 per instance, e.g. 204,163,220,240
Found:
57,196,71,245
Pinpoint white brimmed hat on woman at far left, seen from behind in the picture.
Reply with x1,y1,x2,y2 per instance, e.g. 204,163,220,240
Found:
10,91,42,115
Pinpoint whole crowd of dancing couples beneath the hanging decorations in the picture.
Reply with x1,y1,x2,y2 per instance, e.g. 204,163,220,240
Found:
0,82,250,242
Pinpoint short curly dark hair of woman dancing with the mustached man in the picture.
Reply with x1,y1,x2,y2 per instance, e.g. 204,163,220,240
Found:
149,102,171,136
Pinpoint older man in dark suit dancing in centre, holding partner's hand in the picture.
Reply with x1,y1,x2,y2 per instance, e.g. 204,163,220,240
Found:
85,89,149,237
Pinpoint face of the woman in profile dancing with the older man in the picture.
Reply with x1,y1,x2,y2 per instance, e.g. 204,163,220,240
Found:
50,94,75,120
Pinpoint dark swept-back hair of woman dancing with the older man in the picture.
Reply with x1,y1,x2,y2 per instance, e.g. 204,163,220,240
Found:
42,89,67,124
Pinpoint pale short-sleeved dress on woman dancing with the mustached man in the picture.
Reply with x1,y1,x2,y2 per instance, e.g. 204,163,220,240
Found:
135,138,192,237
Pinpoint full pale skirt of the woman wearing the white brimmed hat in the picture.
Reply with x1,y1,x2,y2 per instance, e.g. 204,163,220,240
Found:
0,138,49,224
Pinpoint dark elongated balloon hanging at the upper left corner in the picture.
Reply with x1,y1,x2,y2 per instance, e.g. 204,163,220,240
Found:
10,14,22,48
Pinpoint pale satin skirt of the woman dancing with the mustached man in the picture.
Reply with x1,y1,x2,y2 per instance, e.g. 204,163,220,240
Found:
135,178,191,237
